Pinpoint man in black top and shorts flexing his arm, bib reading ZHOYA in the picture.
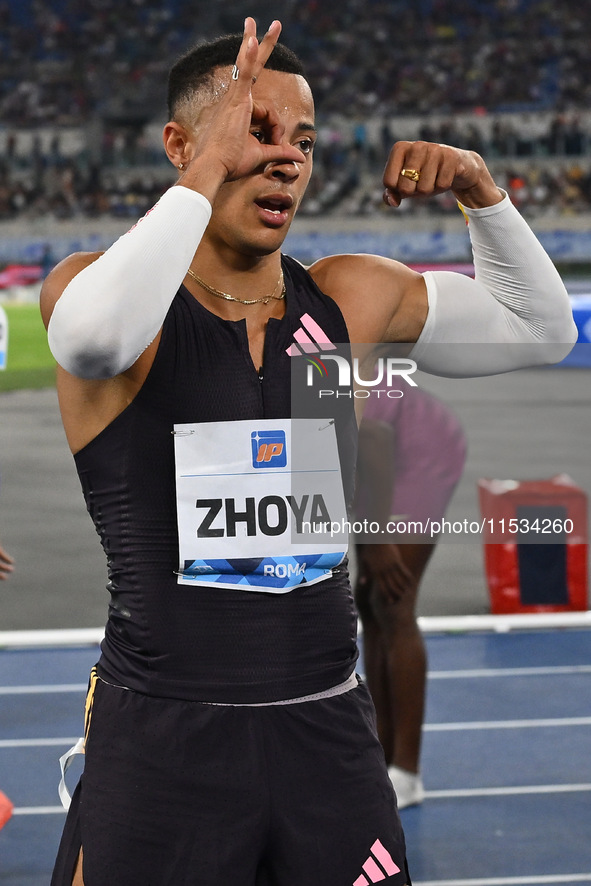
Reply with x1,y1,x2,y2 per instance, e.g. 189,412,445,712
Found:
42,18,574,886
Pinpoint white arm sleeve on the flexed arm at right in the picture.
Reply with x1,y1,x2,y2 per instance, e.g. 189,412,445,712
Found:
410,196,577,376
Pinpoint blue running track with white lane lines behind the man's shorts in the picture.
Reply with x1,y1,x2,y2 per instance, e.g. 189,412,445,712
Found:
0,629,591,886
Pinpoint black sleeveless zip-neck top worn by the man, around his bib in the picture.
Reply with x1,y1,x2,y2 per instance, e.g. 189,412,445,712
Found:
75,257,357,704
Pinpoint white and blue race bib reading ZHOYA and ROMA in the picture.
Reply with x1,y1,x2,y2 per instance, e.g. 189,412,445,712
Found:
174,419,348,594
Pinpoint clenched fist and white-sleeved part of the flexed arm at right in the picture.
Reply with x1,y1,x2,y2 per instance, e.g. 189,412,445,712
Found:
384,142,577,375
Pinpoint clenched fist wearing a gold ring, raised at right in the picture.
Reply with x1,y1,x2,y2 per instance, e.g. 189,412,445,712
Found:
384,141,504,208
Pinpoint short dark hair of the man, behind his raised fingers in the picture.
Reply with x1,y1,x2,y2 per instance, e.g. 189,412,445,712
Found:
168,34,306,120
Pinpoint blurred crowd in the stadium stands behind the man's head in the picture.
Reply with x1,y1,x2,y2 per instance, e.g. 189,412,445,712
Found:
0,0,591,219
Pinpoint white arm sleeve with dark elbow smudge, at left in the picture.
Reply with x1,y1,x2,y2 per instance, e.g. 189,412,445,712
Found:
48,185,211,378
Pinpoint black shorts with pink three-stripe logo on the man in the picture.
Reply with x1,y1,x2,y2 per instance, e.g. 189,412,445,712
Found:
52,680,410,886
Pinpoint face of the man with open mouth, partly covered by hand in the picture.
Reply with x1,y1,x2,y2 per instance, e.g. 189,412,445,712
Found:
199,70,316,255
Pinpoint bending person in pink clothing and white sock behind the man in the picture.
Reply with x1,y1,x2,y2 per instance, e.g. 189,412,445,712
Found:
355,388,466,809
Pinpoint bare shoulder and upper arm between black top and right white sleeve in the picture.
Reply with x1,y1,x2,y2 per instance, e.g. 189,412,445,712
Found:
308,254,427,342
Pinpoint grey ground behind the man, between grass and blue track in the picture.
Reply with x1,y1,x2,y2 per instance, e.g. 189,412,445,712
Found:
0,368,591,630
